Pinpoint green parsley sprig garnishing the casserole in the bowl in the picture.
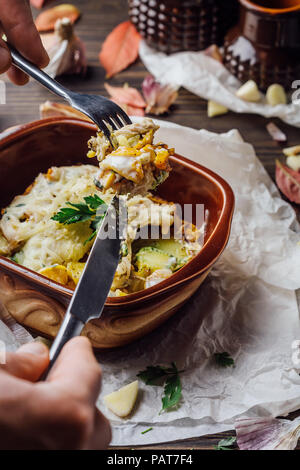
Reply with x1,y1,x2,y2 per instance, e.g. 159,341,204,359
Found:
51,194,107,243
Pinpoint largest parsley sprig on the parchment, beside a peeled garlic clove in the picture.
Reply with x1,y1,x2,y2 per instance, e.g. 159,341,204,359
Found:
137,362,182,411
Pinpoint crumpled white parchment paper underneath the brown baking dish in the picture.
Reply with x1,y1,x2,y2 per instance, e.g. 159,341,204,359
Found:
0,121,300,445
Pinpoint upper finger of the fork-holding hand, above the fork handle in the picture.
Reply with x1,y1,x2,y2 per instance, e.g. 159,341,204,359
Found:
0,0,49,68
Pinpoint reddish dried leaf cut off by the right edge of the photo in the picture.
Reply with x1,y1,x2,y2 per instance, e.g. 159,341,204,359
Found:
276,160,300,204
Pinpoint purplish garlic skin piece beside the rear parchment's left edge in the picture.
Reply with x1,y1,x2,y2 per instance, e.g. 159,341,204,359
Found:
142,75,178,116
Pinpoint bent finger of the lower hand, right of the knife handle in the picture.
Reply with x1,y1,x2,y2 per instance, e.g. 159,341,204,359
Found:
47,336,101,405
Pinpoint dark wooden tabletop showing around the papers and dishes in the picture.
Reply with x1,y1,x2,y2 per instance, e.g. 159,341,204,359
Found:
0,0,300,449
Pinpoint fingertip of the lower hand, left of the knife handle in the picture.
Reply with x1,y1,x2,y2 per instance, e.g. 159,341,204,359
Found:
1,342,49,382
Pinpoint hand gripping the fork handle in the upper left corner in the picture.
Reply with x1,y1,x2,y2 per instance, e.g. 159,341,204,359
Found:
0,0,49,85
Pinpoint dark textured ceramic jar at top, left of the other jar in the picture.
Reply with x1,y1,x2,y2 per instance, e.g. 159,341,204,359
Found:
129,0,238,54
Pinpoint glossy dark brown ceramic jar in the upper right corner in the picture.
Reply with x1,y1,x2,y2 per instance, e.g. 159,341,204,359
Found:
224,0,300,90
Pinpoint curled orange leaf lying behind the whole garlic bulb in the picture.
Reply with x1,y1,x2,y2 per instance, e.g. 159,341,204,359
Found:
35,3,81,32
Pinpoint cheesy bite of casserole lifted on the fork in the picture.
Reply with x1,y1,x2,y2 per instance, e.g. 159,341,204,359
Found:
88,119,174,196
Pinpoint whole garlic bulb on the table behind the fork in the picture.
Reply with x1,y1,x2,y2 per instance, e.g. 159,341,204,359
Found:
41,18,87,78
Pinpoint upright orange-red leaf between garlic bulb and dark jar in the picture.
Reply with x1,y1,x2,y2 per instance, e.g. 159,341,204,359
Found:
99,21,141,78
